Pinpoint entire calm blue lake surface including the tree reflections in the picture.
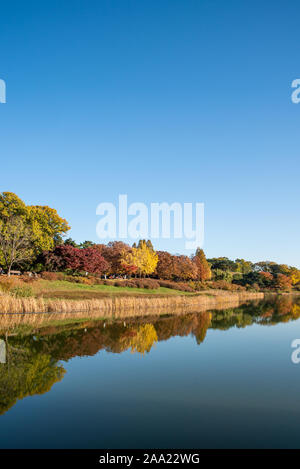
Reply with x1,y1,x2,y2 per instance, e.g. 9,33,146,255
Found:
0,297,300,448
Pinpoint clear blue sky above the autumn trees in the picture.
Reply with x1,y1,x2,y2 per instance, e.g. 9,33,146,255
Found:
0,0,300,267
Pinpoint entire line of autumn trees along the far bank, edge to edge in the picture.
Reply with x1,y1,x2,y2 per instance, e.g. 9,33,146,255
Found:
0,192,300,290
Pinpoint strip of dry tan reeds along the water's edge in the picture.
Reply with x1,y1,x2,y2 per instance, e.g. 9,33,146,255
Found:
0,292,263,332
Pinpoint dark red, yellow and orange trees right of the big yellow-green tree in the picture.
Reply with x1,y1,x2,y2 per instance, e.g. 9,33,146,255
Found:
37,239,211,281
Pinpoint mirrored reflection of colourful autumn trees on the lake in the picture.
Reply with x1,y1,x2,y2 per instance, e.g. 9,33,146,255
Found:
0,296,300,415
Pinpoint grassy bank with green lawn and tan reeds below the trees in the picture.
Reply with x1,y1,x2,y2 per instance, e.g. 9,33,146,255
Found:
0,279,264,327
